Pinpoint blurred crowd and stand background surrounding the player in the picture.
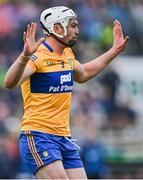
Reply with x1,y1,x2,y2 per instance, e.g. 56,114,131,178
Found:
0,0,143,179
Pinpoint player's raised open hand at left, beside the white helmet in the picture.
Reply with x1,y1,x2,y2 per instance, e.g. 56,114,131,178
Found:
23,22,43,56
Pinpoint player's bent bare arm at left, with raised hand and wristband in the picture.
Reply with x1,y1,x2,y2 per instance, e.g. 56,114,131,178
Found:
4,22,42,89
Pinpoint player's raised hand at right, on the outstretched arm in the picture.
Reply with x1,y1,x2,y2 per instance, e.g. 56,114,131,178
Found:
112,20,129,53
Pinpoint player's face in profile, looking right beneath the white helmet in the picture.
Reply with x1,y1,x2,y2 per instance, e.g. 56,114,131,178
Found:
64,18,79,45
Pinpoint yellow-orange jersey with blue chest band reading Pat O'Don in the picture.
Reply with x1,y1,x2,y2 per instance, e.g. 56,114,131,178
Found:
21,41,76,136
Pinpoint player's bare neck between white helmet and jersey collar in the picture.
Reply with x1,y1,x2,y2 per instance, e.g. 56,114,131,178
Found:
46,37,65,55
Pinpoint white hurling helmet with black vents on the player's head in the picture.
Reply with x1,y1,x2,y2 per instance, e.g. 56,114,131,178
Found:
40,6,77,38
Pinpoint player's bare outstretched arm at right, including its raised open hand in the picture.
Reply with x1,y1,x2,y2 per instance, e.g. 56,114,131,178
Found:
74,20,129,83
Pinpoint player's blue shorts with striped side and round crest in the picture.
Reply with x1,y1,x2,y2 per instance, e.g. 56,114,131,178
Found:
19,131,83,174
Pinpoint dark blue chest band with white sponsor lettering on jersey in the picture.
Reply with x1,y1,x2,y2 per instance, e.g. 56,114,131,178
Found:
30,70,73,93
